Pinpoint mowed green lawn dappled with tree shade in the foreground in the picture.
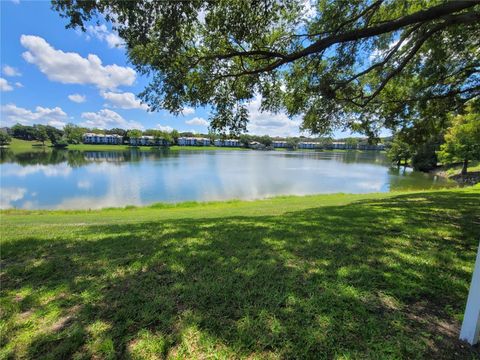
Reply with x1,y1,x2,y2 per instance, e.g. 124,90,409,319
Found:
0,186,480,359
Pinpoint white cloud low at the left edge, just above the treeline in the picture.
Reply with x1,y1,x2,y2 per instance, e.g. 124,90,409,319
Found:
1,104,68,128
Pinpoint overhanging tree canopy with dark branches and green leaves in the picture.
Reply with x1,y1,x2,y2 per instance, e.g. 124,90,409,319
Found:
52,0,480,137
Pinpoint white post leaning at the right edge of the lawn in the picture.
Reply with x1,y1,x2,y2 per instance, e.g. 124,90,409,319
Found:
460,244,480,345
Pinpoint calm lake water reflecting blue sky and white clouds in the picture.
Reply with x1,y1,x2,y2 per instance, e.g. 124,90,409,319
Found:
0,149,453,209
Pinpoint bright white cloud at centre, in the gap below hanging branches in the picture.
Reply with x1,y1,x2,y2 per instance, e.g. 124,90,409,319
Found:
247,96,301,136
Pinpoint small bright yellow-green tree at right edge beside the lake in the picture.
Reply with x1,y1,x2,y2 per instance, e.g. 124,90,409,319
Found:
439,105,480,174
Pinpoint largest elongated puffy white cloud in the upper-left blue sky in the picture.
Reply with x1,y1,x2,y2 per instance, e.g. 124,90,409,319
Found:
20,35,136,89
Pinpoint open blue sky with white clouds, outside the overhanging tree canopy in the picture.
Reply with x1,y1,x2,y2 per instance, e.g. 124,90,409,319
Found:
0,0,382,136
